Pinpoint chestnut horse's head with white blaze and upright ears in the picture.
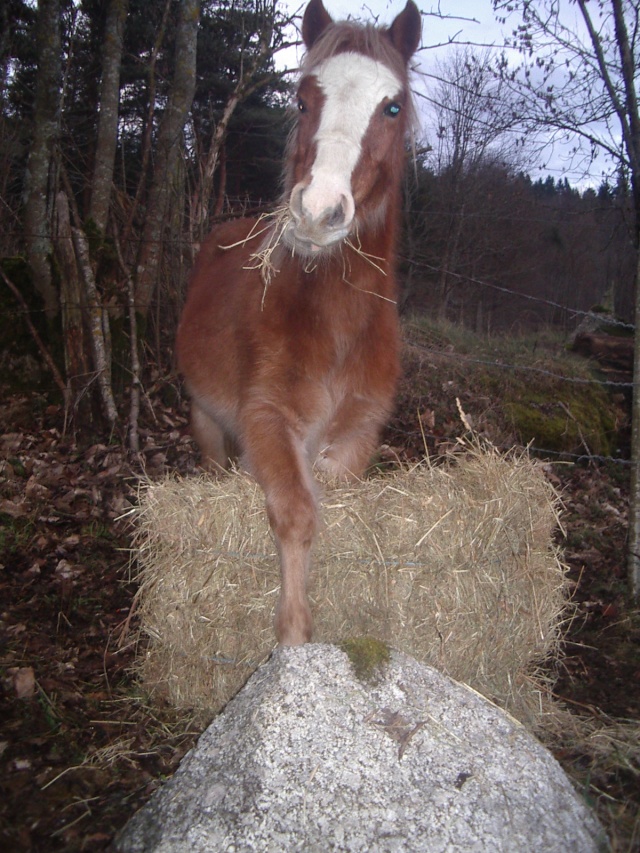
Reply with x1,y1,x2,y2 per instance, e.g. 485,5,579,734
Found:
284,0,421,256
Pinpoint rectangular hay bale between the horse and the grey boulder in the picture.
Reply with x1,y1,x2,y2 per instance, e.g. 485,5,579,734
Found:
135,446,567,728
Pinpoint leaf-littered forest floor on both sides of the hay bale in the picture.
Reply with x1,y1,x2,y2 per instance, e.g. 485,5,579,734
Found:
0,356,640,853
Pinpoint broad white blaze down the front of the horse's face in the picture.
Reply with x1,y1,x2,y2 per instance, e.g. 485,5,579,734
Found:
292,53,402,244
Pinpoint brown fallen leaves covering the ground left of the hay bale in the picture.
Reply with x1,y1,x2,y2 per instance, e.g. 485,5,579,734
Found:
0,406,200,853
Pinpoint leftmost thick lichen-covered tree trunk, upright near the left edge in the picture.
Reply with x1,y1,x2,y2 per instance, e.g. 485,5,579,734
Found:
25,0,62,320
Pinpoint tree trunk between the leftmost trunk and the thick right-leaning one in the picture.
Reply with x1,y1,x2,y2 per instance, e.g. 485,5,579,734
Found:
89,0,129,234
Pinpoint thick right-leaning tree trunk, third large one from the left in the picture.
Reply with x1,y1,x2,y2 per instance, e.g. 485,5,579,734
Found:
136,0,200,317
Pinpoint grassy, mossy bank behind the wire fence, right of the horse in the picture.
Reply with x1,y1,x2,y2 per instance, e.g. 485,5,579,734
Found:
401,317,625,456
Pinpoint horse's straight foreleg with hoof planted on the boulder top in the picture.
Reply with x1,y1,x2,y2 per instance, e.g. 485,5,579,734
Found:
243,412,318,646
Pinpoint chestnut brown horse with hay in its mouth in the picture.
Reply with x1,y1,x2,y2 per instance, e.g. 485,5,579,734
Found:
177,0,421,645
